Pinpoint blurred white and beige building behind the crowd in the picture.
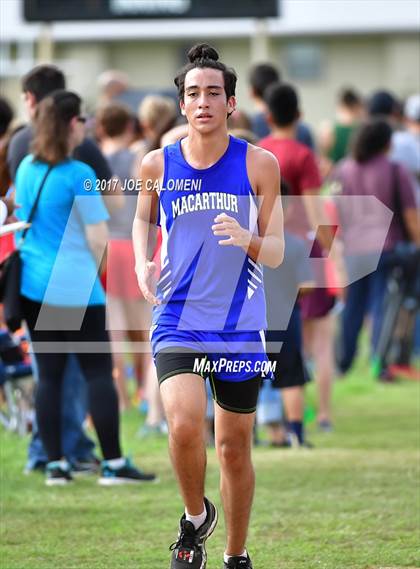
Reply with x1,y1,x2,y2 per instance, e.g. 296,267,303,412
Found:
0,0,420,125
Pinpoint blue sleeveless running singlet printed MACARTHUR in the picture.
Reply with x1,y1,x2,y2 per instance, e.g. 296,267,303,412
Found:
153,136,266,332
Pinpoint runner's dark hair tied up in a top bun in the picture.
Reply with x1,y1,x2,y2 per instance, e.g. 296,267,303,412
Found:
174,43,237,100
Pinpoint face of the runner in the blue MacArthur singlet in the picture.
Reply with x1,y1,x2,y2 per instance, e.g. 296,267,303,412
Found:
181,67,236,134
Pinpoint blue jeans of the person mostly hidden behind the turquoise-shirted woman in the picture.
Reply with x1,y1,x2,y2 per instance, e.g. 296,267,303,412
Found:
26,354,95,470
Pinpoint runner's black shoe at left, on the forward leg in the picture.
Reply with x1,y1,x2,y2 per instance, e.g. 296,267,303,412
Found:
169,498,217,569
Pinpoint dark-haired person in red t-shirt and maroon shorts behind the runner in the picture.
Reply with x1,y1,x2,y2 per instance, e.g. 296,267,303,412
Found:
259,83,334,430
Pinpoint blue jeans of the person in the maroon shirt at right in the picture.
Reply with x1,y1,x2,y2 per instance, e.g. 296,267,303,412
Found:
337,251,390,373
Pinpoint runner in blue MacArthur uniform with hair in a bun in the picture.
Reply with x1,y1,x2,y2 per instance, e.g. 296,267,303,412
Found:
133,44,284,569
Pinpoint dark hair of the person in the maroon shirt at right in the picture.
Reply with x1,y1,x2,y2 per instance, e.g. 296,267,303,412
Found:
352,119,392,164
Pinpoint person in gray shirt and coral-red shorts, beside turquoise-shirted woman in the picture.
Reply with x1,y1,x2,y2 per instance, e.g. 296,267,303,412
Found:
96,102,165,433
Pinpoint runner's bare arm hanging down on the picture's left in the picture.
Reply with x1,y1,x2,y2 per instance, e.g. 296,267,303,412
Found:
133,149,164,305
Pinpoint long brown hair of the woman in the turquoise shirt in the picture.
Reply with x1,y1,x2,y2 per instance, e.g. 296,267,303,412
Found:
31,90,82,164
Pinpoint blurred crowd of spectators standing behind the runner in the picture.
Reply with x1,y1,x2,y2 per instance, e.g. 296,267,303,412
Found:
0,56,420,474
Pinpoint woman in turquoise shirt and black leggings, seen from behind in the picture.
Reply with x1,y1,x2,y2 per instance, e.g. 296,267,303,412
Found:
16,90,154,485
